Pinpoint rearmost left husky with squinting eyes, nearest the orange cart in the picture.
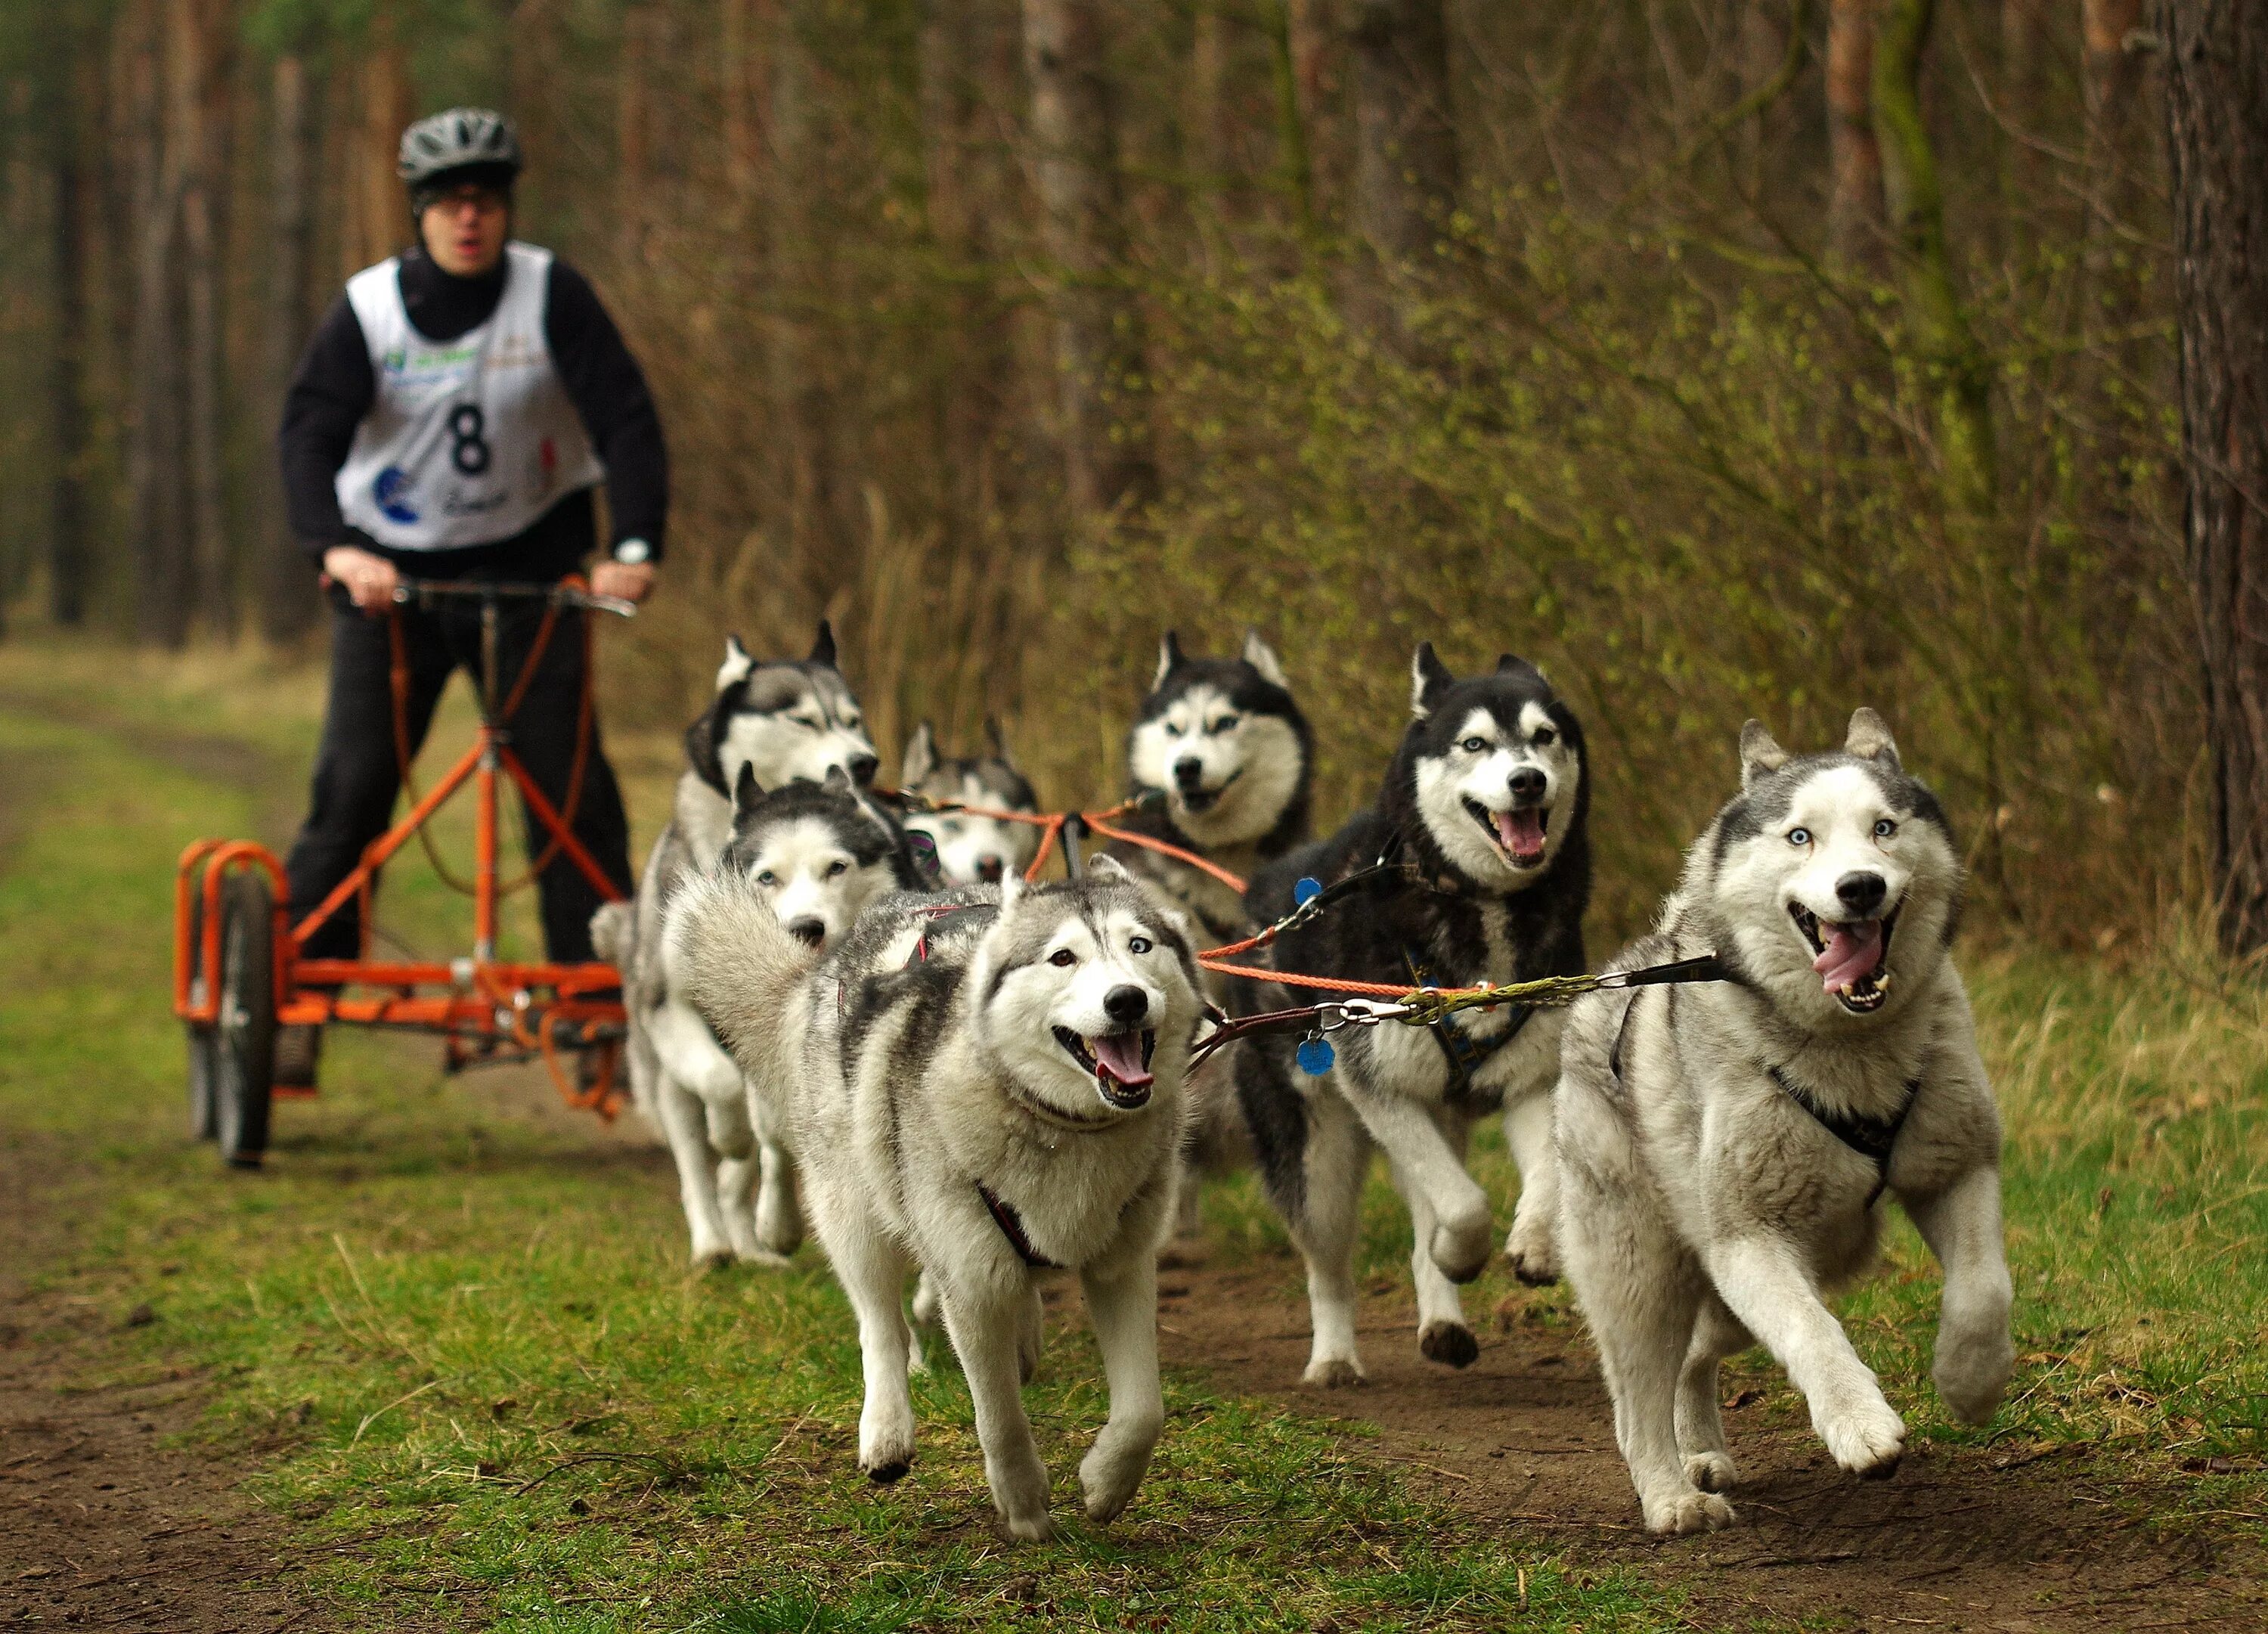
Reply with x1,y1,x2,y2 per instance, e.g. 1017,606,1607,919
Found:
592,622,896,1262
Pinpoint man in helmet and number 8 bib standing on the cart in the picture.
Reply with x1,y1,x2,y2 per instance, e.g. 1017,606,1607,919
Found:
277,109,669,1085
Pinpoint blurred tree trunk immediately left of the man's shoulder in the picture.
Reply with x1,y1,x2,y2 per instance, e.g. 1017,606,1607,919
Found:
254,52,320,642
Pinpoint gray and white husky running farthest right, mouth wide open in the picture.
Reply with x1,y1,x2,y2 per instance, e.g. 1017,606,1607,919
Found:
1556,708,2012,1532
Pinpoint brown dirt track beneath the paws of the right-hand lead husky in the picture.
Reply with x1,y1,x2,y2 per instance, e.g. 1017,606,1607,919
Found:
1161,1257,2268,1629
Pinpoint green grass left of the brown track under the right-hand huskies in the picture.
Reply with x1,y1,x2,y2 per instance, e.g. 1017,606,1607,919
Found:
0,649,1706,1632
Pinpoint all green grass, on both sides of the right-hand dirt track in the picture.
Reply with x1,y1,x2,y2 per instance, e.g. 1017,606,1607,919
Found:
0,649,2268,1632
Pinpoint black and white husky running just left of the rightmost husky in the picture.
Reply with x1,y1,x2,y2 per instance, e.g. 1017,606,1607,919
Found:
1236,642,1590,1384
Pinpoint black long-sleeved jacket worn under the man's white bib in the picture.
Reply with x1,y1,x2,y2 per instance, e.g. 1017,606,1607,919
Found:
277,250,669,578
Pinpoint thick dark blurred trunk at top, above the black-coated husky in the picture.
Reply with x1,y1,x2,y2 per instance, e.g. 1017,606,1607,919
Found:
1354,0,1456,343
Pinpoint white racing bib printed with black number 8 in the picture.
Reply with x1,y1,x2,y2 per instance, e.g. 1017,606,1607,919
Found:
336,243,606,551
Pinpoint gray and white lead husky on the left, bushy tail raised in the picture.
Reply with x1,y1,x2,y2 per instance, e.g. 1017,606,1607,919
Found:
669,858,1200,1539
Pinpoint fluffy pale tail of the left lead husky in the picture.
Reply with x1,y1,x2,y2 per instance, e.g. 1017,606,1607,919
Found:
662,872,816,1085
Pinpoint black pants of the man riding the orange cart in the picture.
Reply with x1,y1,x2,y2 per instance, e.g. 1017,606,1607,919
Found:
286,592,631,963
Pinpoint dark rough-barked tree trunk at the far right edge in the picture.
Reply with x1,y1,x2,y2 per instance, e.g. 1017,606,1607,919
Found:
2152,0,2268,956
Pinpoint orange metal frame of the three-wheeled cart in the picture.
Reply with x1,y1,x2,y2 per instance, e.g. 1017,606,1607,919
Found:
172,585,626,1121
